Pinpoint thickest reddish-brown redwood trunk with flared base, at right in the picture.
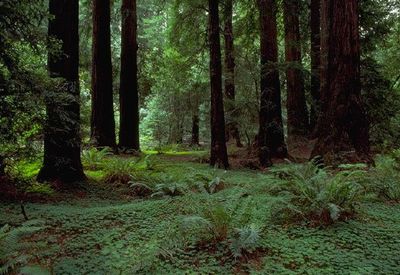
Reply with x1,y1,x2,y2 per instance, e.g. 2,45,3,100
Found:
312,0,371,164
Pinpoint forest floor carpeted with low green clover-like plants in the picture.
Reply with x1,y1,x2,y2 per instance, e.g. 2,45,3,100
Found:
0,151,400,274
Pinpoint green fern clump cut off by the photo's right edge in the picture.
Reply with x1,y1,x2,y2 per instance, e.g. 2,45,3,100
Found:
364,155,400,202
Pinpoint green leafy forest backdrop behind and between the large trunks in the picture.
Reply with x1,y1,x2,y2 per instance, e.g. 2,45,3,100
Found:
0,0,400,181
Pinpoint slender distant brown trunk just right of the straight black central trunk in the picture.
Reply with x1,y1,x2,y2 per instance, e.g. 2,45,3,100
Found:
224,0,243,147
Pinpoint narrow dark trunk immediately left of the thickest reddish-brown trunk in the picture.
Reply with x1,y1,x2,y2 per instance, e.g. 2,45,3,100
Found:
310,0,321,131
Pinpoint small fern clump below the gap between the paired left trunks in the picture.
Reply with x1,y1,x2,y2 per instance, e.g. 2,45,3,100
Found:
104,158,137,184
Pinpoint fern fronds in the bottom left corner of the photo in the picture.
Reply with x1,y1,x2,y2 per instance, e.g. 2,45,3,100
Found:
0,222,40,274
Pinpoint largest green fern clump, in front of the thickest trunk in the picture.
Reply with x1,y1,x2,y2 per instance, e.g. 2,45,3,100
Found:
271,161,366,224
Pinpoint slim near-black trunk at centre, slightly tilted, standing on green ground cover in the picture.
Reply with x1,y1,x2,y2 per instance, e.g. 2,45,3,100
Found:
208,0,229,169
